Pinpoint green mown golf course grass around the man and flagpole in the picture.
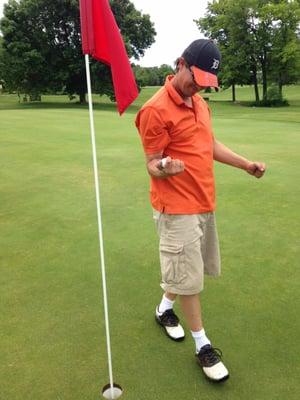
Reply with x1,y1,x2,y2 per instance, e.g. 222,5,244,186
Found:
0,86,300,400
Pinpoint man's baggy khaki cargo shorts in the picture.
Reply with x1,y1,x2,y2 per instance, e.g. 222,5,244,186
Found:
153,210,221,295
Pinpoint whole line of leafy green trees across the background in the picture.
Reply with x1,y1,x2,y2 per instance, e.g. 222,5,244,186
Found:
0,0,300,105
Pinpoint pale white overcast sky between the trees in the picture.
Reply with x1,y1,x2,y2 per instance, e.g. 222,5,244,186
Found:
0,0,208,67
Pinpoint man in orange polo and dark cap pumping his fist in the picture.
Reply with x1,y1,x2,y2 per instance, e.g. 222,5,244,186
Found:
136,39,265,381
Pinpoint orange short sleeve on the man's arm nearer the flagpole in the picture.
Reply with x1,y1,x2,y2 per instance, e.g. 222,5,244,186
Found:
135,107,171,154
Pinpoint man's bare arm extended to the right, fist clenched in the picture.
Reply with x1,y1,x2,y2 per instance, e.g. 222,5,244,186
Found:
214,139,266,178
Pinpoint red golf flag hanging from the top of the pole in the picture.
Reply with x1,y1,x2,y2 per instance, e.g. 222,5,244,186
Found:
80,0,138,114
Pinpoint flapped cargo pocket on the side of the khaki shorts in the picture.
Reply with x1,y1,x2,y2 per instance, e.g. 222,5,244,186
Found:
159,240,187,285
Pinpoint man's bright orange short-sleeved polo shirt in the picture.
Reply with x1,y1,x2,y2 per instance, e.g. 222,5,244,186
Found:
136,76,215,214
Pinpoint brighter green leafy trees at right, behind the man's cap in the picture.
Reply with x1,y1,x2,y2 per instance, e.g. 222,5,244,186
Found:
196,0,299,102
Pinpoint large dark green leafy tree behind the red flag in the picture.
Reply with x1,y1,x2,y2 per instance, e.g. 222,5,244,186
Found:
0,0,156,102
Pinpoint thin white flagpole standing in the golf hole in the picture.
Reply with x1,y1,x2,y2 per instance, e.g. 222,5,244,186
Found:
85,54,114,399
